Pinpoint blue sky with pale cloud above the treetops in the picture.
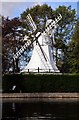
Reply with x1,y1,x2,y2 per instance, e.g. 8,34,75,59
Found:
0,0,79,18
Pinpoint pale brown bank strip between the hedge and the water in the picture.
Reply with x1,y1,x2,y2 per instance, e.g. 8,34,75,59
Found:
0,93,79,99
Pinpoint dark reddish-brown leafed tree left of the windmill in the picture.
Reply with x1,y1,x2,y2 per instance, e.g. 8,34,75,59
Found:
2,17,22,73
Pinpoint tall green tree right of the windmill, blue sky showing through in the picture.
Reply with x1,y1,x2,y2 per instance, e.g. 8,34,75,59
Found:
54,6,76,72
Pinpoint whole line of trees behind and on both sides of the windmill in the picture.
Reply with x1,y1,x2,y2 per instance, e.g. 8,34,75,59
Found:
2,4,79,74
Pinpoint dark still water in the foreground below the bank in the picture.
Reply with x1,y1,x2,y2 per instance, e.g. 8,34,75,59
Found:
2,99,79,120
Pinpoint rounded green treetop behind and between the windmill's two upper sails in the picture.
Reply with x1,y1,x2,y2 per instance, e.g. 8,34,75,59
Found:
21,4,53,31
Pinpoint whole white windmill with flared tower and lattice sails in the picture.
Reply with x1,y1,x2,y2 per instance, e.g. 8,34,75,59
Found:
13,14,62,72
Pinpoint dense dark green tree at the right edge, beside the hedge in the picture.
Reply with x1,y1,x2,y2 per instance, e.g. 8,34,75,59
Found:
68,21,79,73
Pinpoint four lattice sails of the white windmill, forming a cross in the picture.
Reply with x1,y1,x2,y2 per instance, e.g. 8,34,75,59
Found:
13,14,62,59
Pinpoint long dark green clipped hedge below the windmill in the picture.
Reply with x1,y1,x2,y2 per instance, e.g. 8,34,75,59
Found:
2,74,79,93
